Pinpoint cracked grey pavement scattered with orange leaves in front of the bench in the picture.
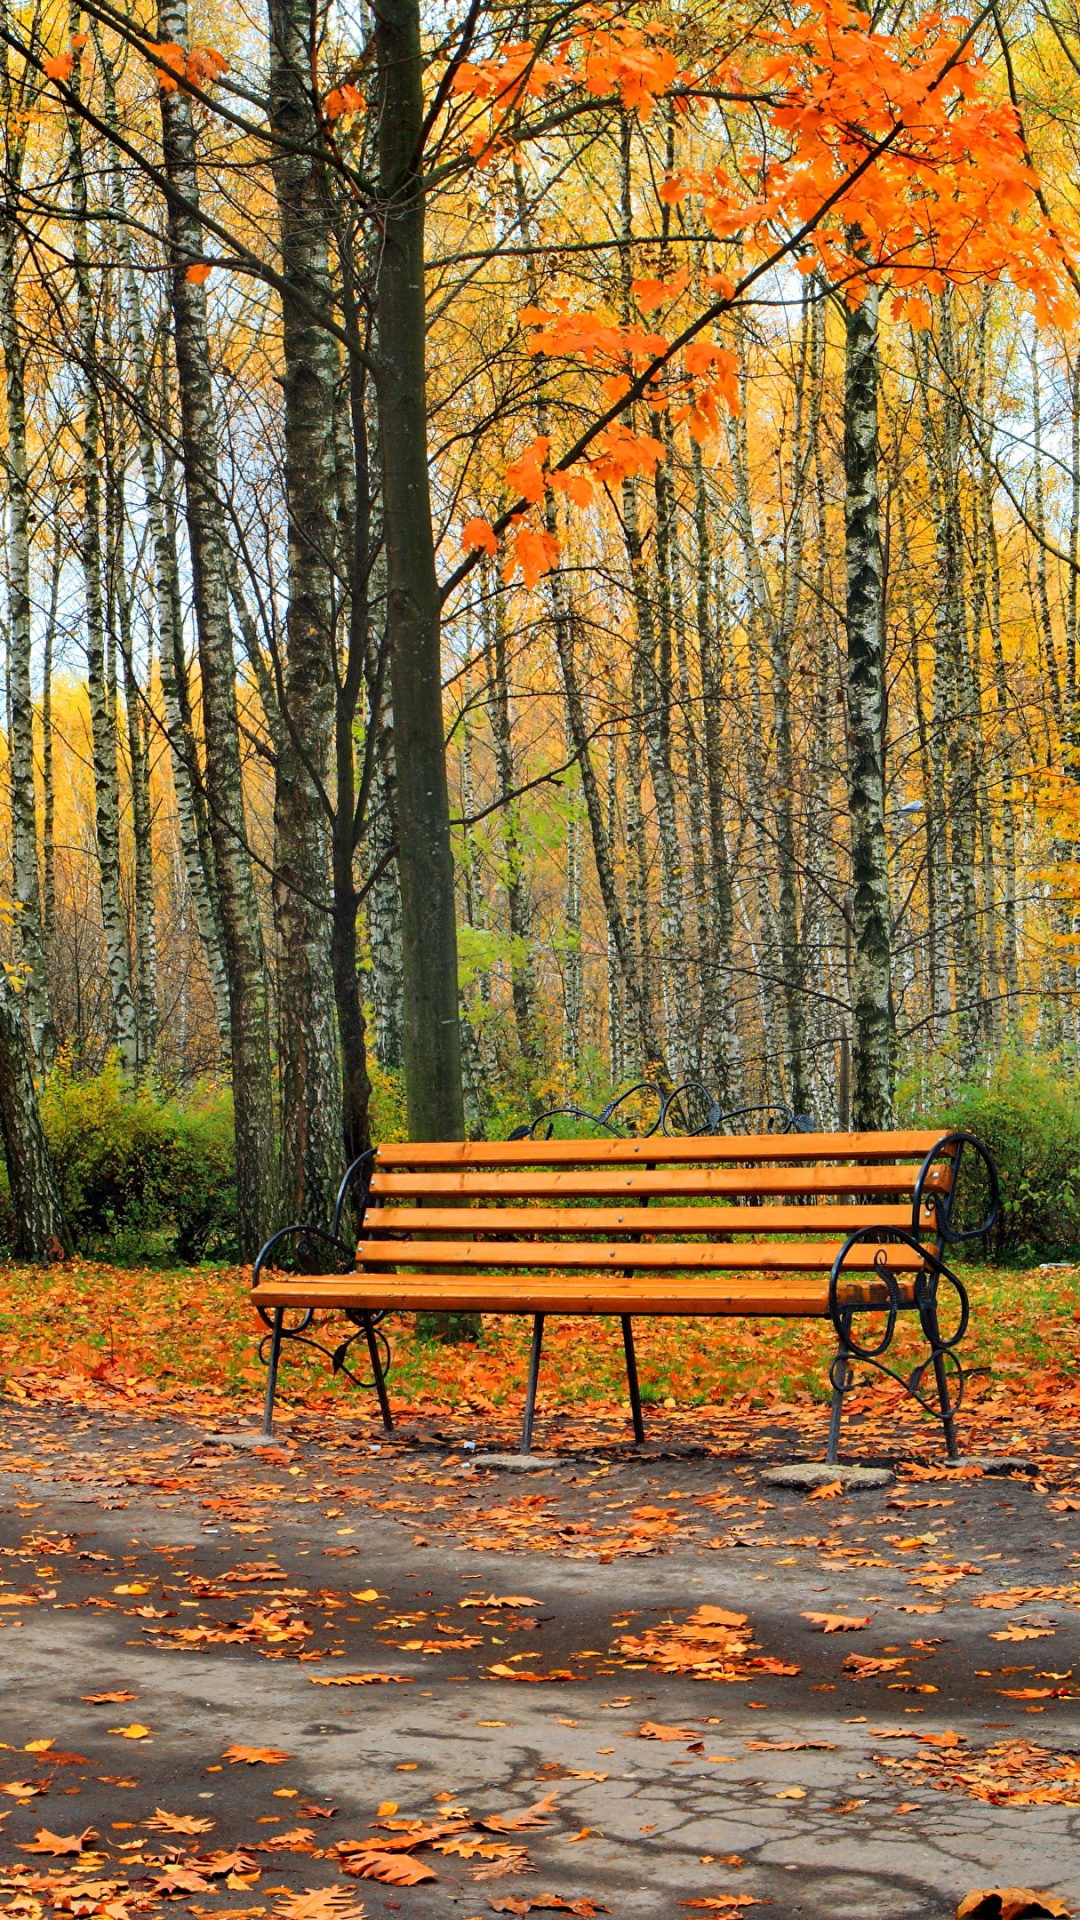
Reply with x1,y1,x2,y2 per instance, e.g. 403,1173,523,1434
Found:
0,1409,1080,1920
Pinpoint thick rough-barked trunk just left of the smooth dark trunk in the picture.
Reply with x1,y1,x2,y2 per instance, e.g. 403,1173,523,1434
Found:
269,0,342,1219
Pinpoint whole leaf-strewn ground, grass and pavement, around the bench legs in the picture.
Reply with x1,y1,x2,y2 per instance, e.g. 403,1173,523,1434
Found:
0,1265,1080,1920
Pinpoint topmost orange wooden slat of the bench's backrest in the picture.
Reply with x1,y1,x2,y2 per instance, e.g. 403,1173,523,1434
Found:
379,1129,944,1169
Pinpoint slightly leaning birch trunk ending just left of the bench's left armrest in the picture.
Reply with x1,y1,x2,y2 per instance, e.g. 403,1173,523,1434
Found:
158,0,277,1258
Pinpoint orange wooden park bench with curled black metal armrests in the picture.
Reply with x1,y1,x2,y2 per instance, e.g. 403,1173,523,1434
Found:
252,1131,997,1461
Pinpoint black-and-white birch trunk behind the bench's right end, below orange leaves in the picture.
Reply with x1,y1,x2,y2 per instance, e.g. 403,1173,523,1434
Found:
844,286,892,1131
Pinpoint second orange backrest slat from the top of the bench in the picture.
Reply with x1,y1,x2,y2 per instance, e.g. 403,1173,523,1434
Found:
371,1165,937,1200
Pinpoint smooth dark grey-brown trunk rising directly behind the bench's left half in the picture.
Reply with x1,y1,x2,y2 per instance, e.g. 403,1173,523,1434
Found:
373,0,465,1140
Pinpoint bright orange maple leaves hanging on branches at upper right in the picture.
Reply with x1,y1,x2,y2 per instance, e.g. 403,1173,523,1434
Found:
454,0,1074,588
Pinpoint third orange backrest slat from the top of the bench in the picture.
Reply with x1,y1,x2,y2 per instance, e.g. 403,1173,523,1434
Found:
363,1202,926,1258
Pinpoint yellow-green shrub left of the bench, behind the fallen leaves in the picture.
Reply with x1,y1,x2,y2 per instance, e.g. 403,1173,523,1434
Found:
42,1062,236,1261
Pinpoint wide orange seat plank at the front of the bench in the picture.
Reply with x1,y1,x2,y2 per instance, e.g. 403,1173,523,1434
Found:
252,1275,913,1319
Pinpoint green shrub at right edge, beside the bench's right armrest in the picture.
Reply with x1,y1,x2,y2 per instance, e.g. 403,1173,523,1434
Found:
932,1058,1080,1261
